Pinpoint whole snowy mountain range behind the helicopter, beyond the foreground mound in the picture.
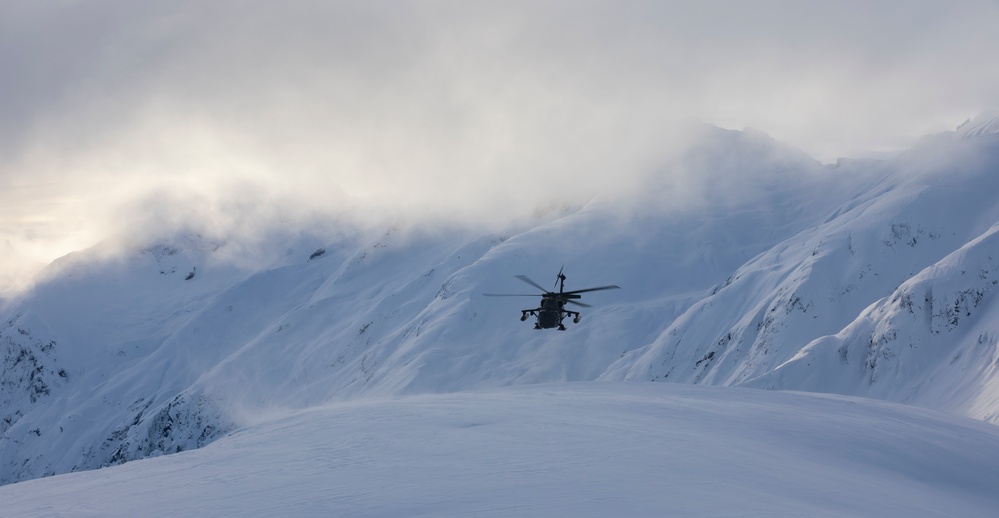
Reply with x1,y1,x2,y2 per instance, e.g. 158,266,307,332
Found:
0,115,999,492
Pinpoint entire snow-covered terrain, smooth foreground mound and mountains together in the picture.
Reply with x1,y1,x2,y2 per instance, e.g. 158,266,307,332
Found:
0,117,999,516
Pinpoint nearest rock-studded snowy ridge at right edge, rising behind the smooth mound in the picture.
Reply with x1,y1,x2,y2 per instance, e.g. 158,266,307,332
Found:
749,222,999,421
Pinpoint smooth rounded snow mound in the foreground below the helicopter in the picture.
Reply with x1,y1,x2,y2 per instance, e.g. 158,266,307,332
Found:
0,383,999,517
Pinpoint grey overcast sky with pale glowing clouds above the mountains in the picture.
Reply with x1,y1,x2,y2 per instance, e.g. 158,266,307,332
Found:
0,0,999,260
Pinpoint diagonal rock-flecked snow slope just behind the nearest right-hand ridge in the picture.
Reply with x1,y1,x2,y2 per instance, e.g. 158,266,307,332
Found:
608,134,999,398
